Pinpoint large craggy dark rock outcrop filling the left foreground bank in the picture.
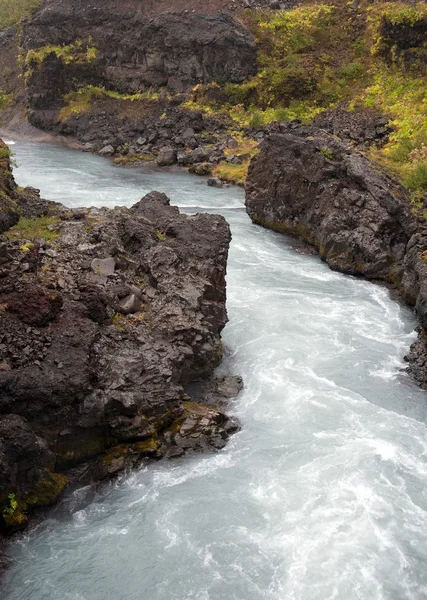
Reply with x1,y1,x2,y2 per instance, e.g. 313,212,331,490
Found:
0,142,241,531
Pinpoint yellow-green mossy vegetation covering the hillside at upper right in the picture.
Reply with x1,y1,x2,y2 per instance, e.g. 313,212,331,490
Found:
185,0,427,192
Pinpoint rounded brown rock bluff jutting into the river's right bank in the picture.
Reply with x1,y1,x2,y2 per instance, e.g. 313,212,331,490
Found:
246,126,416,285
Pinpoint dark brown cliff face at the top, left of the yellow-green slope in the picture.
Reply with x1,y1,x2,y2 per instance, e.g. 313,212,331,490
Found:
23,0,256,109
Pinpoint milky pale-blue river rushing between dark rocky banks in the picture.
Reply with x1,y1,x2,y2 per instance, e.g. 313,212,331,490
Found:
0,142,427,600
